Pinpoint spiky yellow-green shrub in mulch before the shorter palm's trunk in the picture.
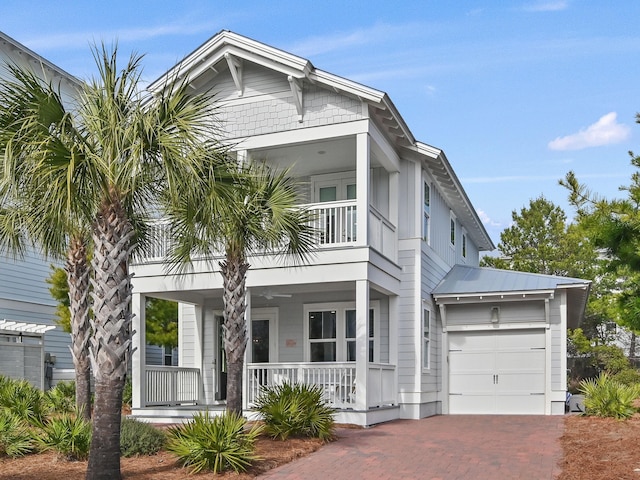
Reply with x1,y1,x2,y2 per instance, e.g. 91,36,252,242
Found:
167,412,262,473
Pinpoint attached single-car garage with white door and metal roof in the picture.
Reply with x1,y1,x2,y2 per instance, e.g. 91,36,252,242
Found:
433,265,590,415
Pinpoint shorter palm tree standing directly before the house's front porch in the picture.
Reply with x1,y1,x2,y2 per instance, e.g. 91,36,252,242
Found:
170,160,315,414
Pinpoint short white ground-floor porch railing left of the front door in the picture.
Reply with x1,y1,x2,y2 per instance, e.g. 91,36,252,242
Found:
145,365,202,407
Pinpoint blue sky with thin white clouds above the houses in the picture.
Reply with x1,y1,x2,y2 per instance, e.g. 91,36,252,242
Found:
0,0,640,248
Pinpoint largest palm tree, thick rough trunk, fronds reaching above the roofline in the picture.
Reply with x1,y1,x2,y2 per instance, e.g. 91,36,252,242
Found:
0,45,225,479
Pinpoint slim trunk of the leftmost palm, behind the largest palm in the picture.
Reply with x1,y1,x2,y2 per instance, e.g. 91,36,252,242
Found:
66,237,91,420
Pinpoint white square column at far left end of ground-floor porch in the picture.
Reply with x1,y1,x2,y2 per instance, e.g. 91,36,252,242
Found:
131,293,147,409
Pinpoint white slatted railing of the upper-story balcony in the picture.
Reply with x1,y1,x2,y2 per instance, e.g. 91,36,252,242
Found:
134,200,396,263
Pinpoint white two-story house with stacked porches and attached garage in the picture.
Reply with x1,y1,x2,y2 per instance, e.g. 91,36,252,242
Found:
133,31,589,425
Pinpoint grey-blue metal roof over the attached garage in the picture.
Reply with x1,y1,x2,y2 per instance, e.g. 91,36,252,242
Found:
433,265,591,297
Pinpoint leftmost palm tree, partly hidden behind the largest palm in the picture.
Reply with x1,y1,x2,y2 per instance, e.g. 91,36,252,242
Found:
0,65,91,419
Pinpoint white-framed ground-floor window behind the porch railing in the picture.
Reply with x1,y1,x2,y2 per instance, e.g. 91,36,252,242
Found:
306,304,379,362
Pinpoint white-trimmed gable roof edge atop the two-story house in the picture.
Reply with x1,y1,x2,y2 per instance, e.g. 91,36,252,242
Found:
149,30,495,251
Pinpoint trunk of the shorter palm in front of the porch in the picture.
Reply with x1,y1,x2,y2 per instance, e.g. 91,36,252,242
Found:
220,259,249,415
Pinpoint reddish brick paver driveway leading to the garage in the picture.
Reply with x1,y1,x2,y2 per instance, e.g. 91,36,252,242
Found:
260,415,564,480
